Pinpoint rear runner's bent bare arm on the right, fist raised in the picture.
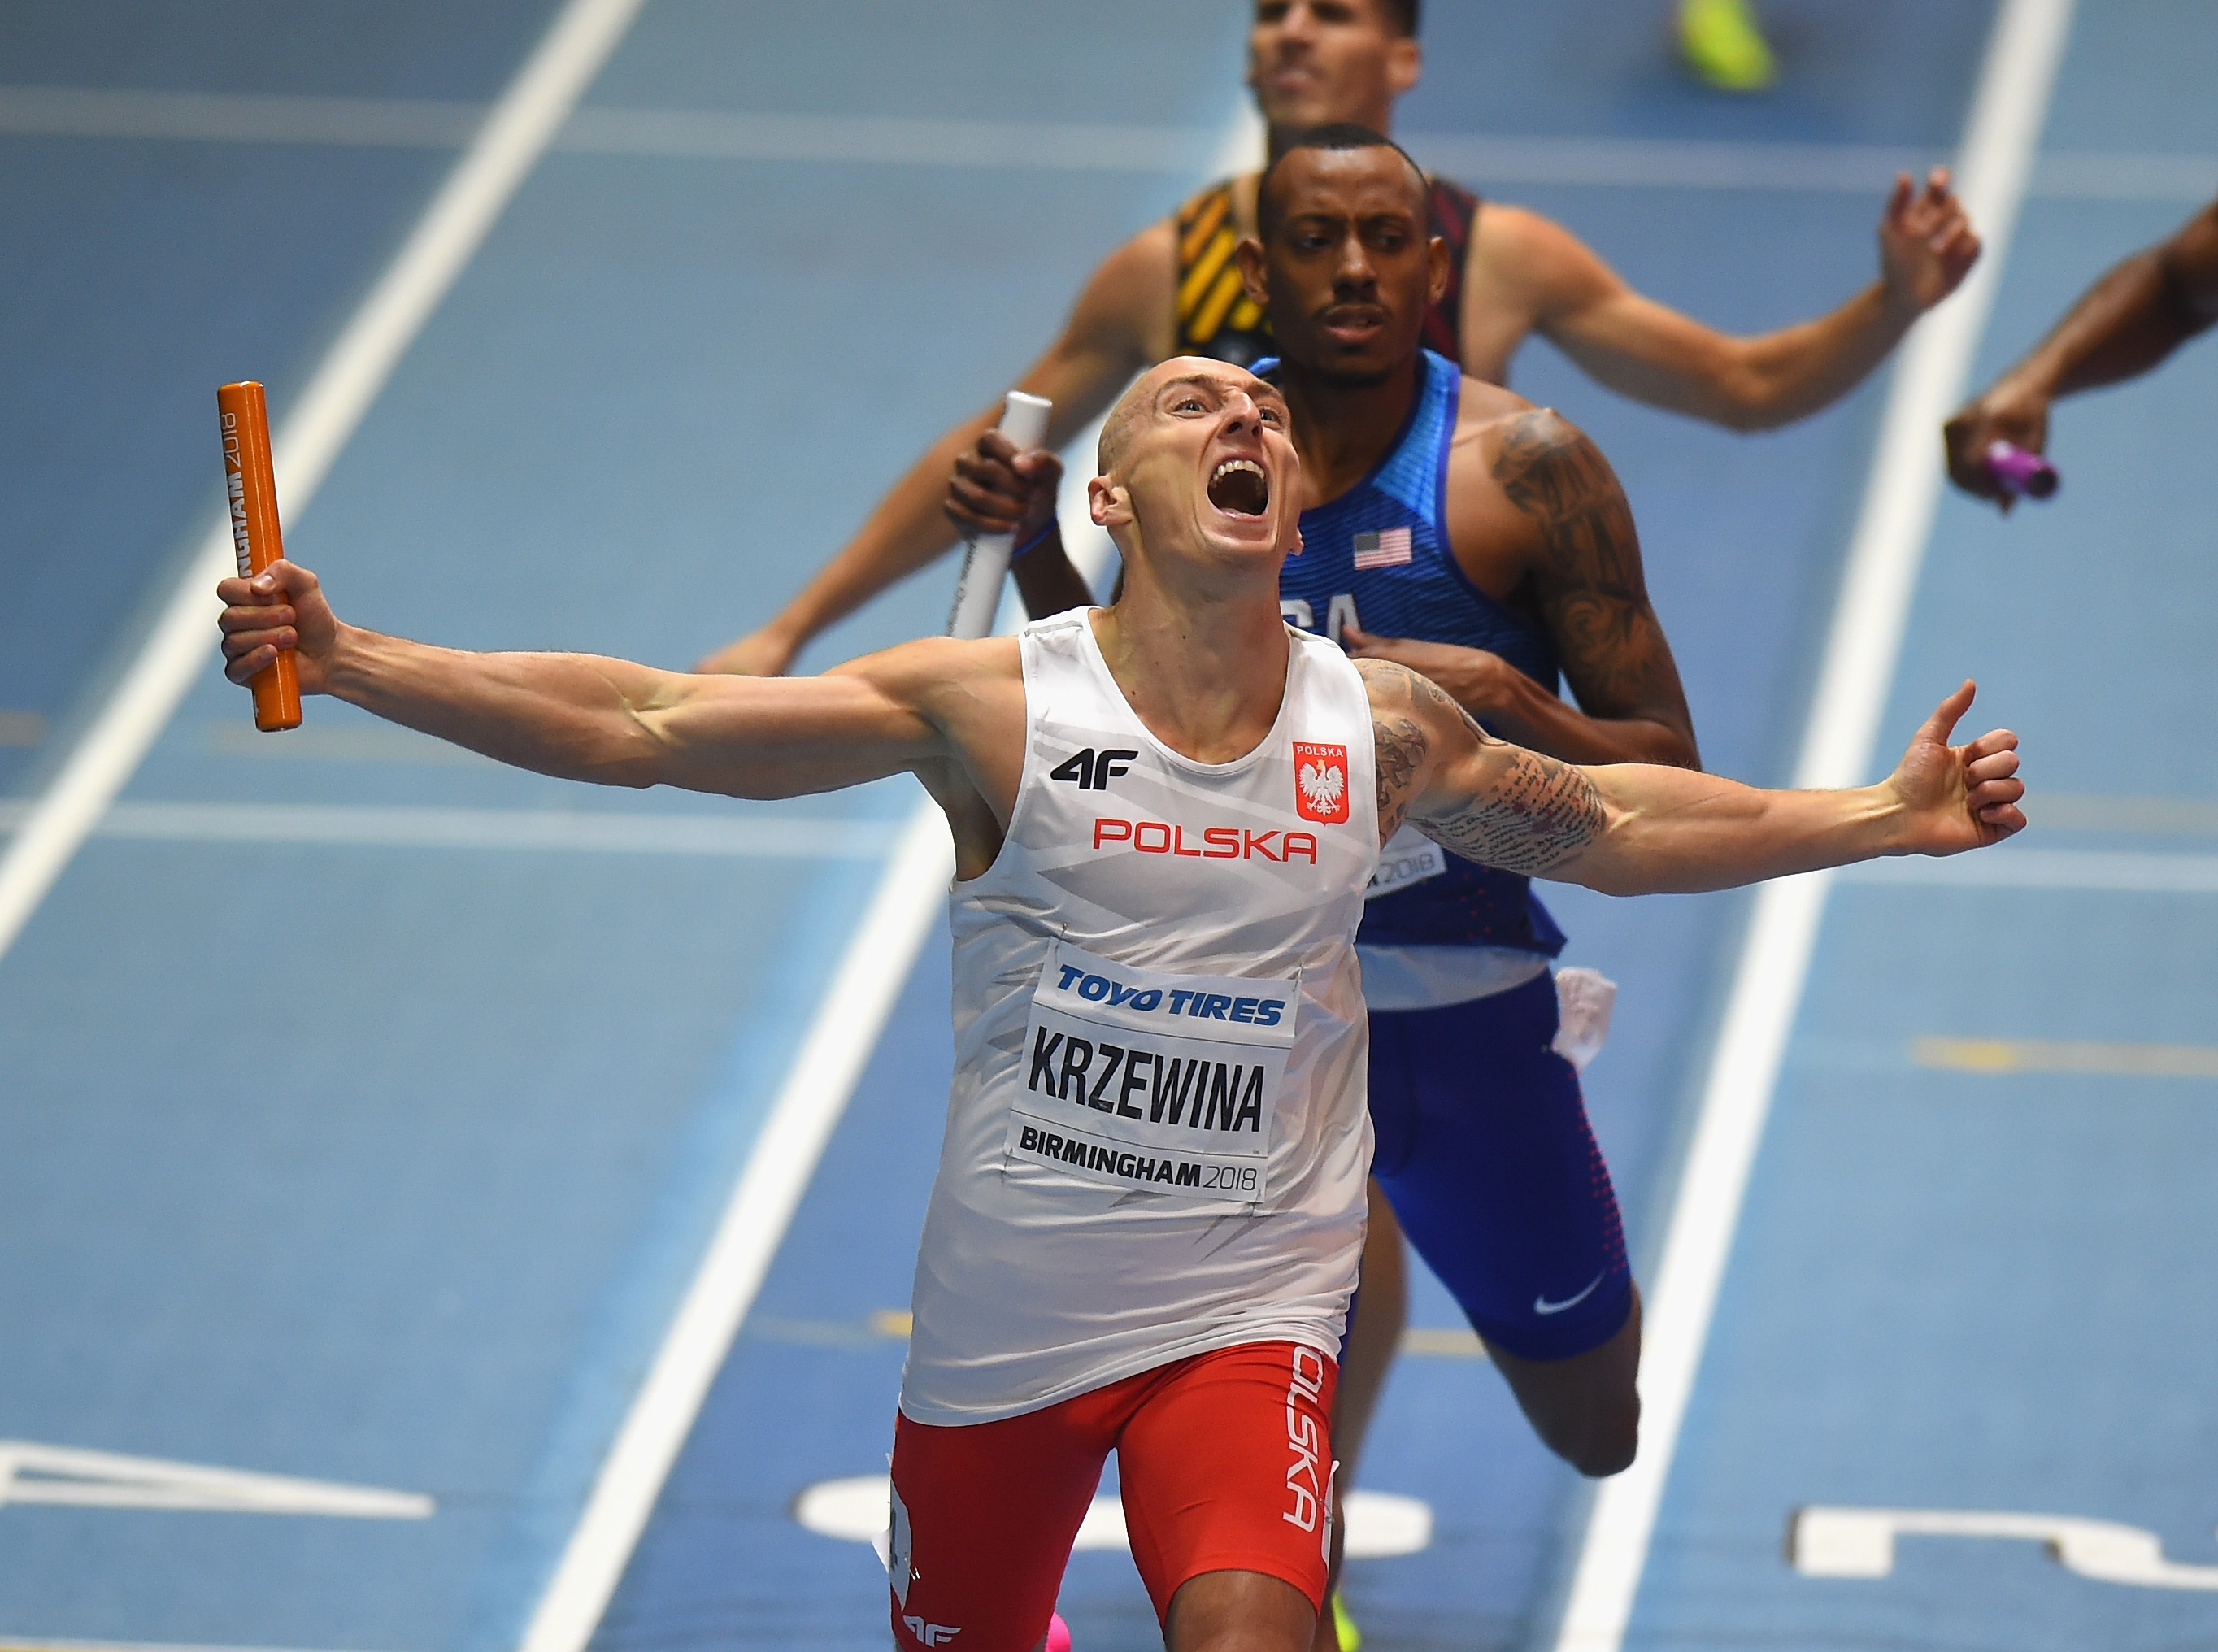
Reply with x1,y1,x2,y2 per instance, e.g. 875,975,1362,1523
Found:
1463,168,1978,430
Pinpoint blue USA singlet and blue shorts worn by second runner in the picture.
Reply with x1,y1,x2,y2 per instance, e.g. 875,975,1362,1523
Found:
1253,350,1633,1359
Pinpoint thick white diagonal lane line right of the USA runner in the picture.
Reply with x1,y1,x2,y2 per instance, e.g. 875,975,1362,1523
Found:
1555,0,2072,1652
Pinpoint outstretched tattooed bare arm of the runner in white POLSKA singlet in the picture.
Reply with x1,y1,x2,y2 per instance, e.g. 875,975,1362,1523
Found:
1359,661,2025,896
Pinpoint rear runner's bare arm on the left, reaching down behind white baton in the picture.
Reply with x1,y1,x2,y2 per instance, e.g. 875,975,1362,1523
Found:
698,220,1178,676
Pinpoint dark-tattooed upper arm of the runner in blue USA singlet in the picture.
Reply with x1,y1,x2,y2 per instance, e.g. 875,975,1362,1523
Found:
1493,408,1692,743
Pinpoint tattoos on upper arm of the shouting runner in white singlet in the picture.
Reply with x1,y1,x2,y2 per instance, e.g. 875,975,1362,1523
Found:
1355,659,1606,876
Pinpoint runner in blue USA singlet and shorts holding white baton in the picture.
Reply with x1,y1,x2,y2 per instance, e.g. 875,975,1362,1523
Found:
950,126,1699,1641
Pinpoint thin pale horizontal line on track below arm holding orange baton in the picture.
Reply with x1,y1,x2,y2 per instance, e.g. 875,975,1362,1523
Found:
0,802,901,860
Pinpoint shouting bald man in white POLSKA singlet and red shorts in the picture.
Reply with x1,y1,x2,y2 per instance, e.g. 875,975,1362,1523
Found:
217,359,2025,1652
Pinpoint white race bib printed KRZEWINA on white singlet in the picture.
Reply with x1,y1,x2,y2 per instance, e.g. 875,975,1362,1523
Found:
1007,942,1300,1206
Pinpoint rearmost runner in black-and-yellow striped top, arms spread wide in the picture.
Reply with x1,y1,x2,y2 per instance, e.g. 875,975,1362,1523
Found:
701,0,1978,676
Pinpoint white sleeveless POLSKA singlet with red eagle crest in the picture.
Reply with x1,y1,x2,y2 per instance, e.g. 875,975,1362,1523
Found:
901,610,1380,1426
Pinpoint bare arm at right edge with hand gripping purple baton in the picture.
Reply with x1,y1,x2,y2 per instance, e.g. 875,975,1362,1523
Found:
1947,202,2218,510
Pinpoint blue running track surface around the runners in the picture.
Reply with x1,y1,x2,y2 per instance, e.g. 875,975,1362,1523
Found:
0,0,2218,1652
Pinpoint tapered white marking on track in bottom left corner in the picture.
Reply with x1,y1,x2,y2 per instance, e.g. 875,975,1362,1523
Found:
0,1439,437,1519
